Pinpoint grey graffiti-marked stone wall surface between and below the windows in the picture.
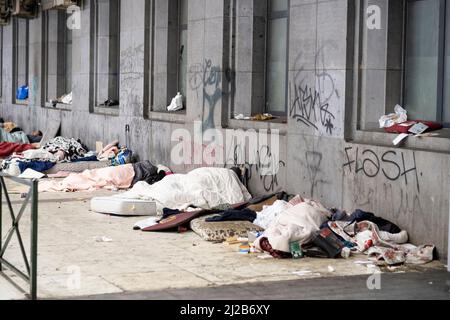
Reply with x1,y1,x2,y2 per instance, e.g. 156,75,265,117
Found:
0,0,450,255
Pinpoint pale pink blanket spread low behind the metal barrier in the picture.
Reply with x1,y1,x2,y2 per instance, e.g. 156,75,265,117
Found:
39,164,134,192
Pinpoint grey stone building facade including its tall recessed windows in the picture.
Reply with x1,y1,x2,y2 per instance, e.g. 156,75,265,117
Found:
0,0,450,255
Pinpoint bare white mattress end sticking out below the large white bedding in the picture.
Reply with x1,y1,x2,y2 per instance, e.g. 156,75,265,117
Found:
91,197,156,216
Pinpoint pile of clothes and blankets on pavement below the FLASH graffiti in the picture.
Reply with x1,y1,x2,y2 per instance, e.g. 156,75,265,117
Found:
248,196,435,265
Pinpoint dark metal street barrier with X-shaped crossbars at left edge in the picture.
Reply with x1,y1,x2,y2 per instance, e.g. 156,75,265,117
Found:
0,173,38,300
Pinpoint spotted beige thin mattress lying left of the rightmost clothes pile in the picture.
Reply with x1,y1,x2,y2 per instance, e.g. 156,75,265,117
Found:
190,215,264,242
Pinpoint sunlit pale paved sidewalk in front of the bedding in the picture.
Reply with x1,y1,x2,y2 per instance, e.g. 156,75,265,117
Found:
0,180,444,299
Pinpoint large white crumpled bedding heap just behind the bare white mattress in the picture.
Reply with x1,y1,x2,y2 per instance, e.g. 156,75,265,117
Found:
115,168,251,215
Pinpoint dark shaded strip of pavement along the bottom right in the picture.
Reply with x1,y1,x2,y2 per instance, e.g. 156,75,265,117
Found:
81,271,450,301
